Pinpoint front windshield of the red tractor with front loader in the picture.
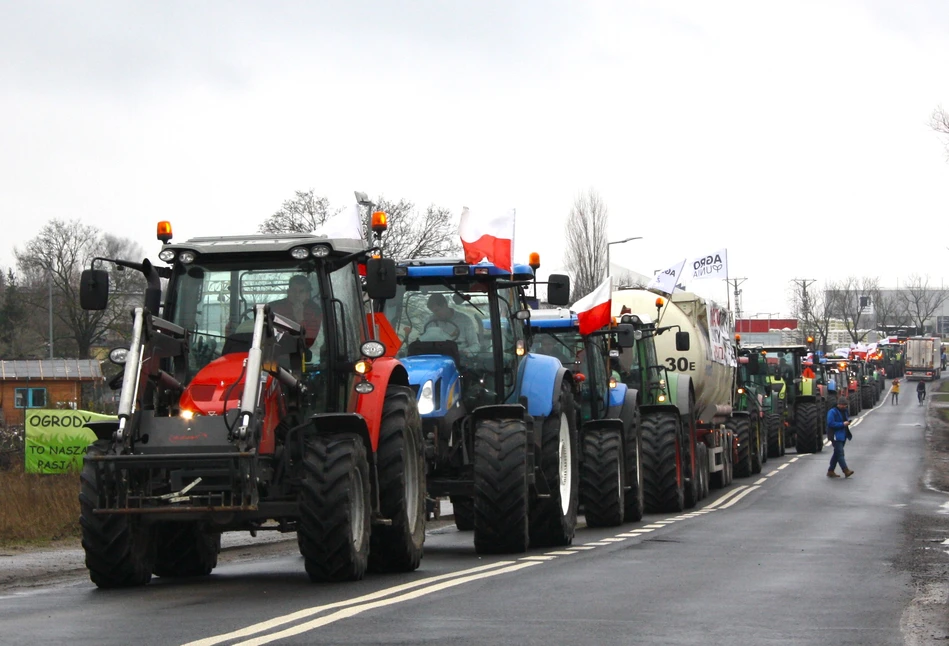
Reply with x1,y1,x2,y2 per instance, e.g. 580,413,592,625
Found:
172,265,322,373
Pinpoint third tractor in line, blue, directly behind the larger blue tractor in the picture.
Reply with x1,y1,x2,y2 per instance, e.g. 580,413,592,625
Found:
531,309,644,527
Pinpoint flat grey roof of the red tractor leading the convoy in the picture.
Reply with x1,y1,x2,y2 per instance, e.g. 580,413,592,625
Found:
162,233,368,258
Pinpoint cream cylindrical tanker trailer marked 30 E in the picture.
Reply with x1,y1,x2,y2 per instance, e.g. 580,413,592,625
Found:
612,289,748,512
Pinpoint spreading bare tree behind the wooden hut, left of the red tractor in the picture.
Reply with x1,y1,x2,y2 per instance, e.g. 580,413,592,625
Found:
14,219,144,359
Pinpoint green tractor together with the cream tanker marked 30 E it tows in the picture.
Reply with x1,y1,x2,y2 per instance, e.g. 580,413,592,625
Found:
612,289,736,511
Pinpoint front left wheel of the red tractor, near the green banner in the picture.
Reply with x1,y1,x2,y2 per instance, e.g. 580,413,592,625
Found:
79,440,155,588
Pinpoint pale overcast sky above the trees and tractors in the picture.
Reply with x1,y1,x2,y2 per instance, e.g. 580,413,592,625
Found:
0,0,949,314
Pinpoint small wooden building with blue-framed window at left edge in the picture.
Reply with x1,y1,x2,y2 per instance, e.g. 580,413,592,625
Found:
0,359,105,426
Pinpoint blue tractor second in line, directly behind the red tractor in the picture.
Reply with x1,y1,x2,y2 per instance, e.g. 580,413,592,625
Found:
384,258,579,554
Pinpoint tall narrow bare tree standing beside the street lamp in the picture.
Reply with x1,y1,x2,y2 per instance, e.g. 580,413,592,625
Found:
564,188,609,301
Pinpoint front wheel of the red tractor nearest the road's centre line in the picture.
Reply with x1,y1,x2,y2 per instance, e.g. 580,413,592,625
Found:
297,435,372,582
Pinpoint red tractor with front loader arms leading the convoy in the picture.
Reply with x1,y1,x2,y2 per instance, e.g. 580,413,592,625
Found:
79,219,425,588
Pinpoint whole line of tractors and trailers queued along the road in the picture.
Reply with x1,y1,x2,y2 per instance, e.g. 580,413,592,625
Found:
72,221,883,588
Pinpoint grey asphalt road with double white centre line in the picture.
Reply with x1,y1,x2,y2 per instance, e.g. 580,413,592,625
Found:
0,393,949,646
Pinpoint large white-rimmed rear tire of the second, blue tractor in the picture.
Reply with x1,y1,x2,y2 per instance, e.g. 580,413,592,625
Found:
530,381,580,547
